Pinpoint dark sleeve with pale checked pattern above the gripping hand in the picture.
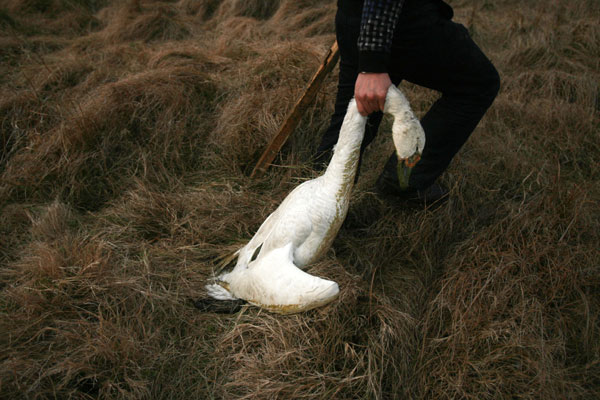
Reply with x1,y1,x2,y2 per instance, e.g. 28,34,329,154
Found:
358,0,405,72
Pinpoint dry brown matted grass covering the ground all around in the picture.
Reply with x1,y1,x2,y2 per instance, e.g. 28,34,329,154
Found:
0,0,600,399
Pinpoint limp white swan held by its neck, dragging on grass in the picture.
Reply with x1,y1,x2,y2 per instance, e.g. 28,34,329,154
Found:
206,86,425,314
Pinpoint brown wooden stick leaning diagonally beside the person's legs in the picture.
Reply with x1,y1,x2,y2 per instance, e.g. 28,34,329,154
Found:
250,42,339,178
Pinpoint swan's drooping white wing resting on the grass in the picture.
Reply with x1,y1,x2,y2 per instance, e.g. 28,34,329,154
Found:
229,244,340,314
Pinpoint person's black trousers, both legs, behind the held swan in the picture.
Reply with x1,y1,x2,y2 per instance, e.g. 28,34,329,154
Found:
315,0,500,189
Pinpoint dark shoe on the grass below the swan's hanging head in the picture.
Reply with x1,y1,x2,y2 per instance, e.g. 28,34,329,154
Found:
376,170,449,207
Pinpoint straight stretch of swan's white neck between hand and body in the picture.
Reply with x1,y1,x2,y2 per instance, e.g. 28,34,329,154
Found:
323,99,367,195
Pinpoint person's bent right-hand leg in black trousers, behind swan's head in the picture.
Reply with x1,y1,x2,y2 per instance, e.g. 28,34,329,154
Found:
384,10,500,189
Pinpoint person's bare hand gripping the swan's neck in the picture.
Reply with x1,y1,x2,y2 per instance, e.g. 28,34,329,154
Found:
354,72,392,117
